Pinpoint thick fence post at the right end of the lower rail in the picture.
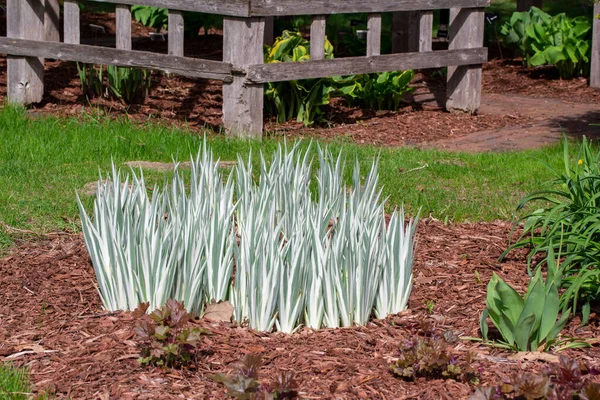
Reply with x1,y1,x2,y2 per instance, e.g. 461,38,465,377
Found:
446,8,484,114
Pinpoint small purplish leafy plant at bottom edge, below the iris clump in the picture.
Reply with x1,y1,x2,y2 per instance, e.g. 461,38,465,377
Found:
212,354,300,400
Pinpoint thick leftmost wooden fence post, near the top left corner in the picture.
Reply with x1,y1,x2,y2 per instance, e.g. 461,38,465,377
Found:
6,0,45,104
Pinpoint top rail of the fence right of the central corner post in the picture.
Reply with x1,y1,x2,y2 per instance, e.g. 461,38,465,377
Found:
248,0,490,17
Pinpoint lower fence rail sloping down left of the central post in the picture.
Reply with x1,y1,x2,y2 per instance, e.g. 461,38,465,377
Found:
0,37,232,82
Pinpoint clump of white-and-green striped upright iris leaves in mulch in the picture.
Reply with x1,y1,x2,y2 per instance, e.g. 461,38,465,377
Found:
79,144,416,332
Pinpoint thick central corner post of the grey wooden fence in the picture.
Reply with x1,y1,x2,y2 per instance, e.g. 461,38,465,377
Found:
223,17,265,138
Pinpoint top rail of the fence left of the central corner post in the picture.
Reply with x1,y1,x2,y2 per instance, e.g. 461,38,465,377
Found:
84,0,250,17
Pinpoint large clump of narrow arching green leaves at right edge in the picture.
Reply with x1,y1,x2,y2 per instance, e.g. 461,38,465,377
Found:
501,137,600,323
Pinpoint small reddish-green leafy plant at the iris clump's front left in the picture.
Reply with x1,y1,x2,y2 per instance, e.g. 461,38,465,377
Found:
134,299,208,368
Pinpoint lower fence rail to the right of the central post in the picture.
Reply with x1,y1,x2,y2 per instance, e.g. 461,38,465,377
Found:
246,47,487,84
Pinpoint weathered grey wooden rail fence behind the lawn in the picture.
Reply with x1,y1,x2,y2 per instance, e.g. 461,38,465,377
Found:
0,0,489,137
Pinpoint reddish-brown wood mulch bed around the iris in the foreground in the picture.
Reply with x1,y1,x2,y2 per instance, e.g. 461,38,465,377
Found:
0,220,600,399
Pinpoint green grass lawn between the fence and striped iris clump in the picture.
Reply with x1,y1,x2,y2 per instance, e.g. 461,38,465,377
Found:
0,107,576,247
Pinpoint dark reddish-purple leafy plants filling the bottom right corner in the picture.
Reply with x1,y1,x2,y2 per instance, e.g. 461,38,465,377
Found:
469,356,600,400
